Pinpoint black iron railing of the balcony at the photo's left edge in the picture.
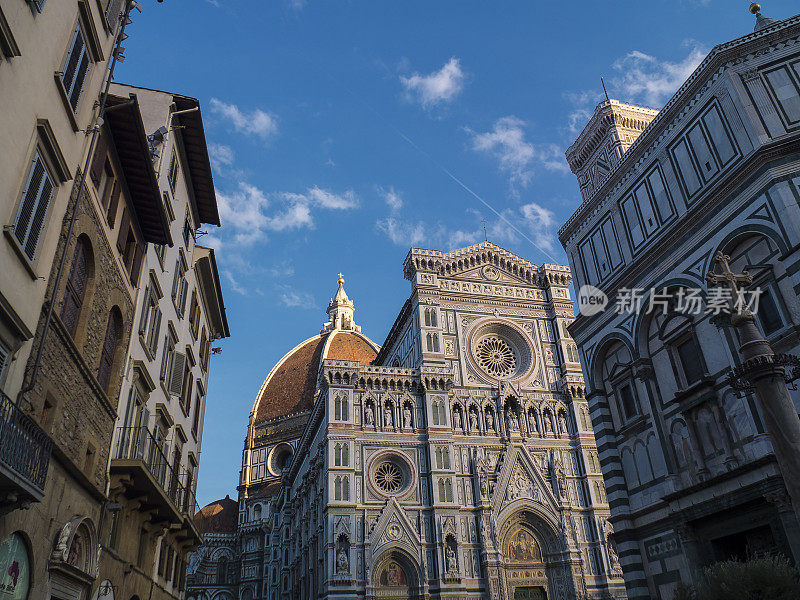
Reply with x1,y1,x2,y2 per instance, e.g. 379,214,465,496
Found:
0,392,53,495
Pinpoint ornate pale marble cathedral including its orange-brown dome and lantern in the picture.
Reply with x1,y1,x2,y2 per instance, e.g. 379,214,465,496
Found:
187,242,625,600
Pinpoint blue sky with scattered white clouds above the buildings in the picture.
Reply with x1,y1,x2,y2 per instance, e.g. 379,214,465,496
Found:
117,0,797,506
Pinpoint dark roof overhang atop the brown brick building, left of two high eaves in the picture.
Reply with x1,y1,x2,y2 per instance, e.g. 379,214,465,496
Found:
104,94,172,246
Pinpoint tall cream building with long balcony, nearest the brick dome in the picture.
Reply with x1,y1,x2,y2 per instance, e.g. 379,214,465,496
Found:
100,83,229,599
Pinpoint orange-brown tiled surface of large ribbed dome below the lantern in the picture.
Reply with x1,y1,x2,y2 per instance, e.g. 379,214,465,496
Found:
252,329,380,423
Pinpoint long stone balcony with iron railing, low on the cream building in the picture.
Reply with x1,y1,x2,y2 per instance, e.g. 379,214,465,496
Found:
111,427,200,543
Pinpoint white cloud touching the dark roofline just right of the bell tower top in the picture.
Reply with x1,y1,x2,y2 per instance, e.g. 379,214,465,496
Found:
612,41,708,108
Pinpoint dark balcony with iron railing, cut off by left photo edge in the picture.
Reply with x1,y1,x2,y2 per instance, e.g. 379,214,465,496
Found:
0,392,53,514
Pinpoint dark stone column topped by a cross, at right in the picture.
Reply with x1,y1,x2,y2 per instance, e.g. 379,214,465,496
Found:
706,252,800,523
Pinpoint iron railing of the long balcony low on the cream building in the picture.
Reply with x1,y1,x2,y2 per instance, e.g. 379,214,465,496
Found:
114,427,197,516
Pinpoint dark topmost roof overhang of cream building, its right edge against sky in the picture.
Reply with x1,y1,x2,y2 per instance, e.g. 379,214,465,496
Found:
173,95,220,226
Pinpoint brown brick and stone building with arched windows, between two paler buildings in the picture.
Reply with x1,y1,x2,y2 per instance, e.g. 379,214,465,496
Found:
0,85,171,600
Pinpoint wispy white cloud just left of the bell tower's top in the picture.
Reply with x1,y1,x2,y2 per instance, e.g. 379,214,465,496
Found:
467,115,569,187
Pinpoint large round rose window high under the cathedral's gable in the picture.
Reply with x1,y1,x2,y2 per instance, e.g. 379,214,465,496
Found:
470,321,534,379
